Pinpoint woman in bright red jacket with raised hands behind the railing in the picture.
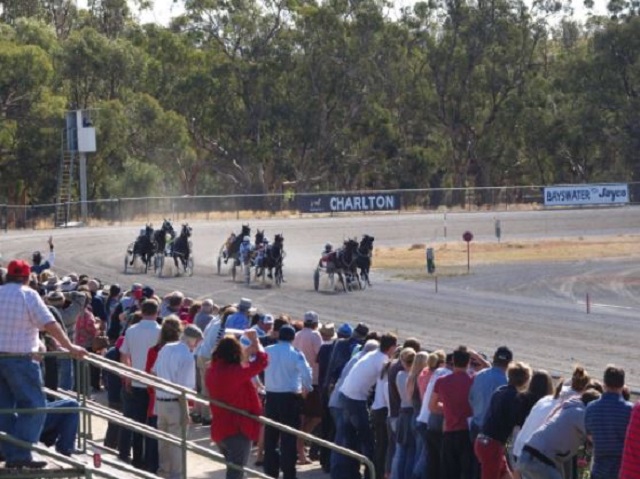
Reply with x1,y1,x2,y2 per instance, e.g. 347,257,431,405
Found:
206,330,268,479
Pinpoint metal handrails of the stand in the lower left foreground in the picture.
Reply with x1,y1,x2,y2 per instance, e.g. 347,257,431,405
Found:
0,353,375,479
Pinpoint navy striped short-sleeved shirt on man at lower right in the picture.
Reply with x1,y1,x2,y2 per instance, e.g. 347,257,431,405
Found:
584,392,633,479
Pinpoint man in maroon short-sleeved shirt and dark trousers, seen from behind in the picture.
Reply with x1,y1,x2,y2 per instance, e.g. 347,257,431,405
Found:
429,346,483,479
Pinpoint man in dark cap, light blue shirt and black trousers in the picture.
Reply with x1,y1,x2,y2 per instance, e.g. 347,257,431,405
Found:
264,325,313,479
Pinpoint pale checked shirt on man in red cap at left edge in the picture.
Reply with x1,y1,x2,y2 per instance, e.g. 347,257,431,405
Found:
0,283,55,354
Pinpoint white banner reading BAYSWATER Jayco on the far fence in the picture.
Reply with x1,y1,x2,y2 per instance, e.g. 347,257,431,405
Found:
544,183,629,206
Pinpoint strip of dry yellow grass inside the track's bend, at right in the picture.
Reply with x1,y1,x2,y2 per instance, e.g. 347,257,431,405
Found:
373,235,640,276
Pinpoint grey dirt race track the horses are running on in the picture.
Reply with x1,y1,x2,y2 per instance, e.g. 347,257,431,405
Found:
0,207,640,389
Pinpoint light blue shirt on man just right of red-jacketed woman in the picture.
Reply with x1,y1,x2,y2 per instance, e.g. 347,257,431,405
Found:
264,341,313,393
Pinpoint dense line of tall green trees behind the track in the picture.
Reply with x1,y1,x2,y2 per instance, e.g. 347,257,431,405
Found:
0,0,640,203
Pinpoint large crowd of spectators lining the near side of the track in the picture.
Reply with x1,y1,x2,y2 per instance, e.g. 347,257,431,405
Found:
0,242,640,479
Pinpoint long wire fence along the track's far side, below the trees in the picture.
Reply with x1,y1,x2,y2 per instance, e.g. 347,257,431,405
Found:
5,183,640,230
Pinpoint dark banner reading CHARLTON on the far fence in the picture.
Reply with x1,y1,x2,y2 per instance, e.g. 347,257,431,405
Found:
298,193,400,213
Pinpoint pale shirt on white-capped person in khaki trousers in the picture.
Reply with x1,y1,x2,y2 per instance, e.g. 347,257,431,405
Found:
153,341,196,399
